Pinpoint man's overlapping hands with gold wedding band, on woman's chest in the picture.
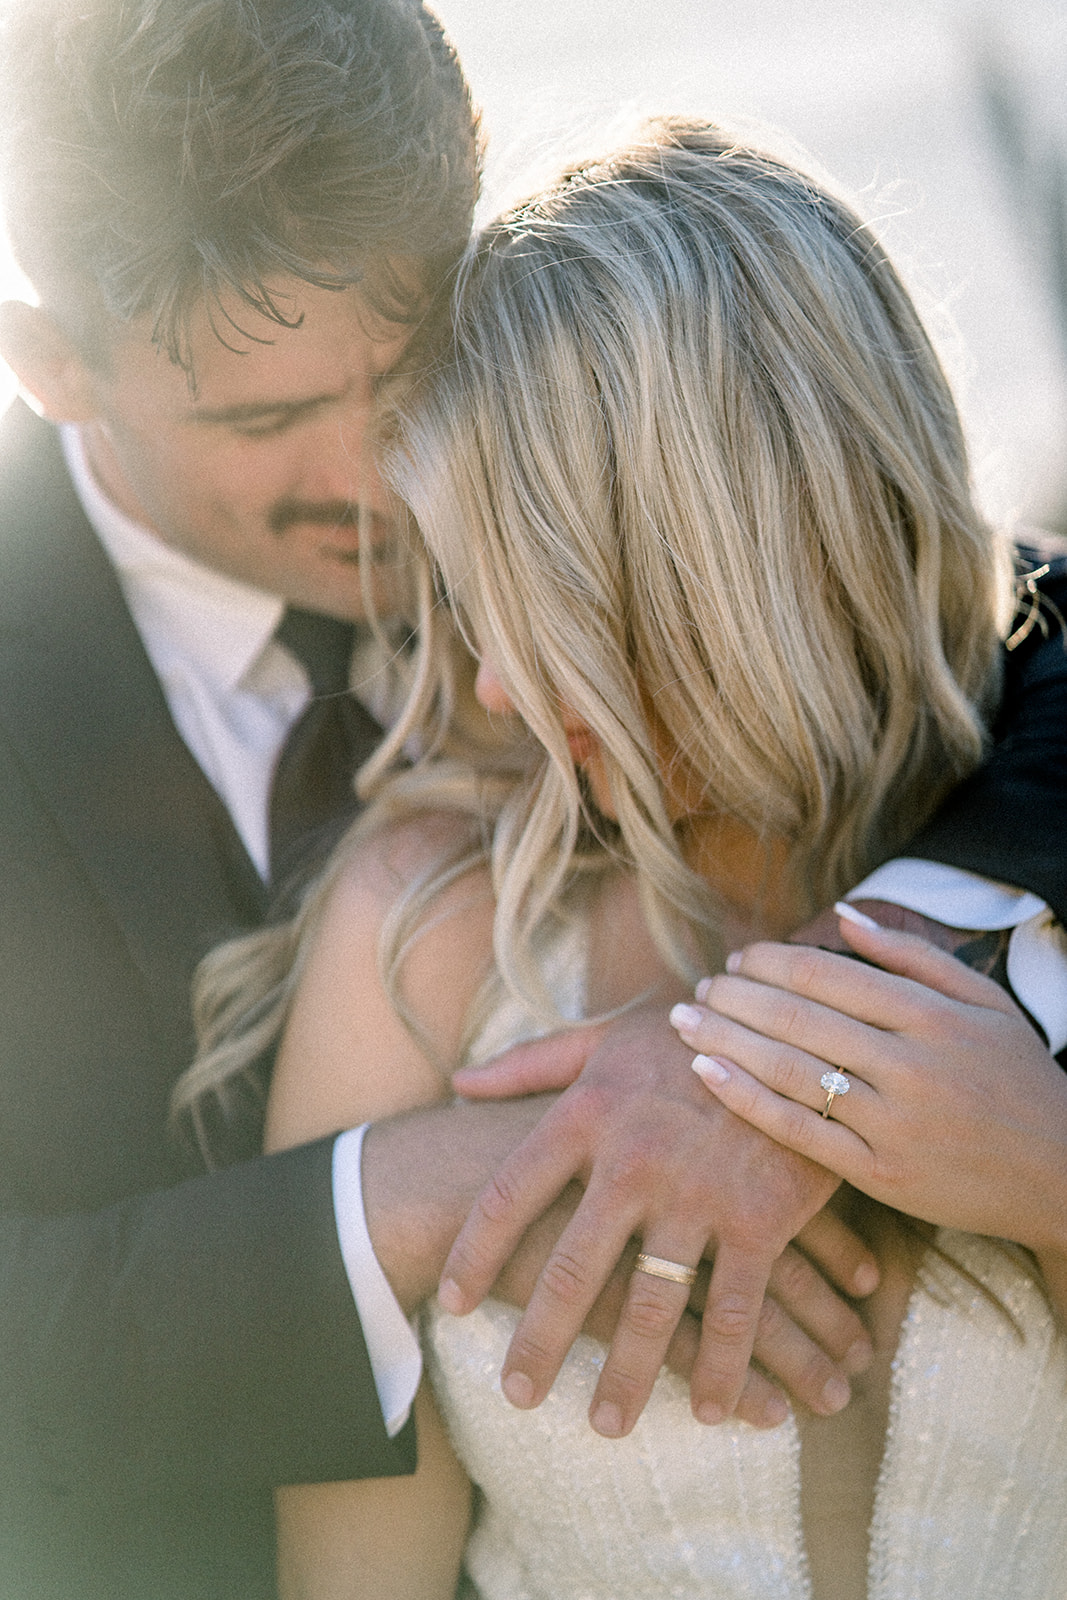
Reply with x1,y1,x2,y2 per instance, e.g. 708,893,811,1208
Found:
440,1006,877,1437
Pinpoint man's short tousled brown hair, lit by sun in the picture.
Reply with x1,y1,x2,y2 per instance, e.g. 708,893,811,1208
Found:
0,0,480,363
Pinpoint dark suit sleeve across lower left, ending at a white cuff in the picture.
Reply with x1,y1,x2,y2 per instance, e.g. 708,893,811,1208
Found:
0,1141,414,1501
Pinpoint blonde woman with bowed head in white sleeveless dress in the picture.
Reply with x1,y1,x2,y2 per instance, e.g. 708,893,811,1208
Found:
187,122,1067,1600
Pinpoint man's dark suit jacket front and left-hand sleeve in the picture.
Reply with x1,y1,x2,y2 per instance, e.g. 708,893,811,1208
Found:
0,406,411,1600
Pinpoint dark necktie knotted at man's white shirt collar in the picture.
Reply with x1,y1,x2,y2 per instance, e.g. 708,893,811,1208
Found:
270,606,382,888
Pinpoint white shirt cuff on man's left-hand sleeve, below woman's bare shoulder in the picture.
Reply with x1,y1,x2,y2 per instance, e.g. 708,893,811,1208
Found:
333,1126,422,1438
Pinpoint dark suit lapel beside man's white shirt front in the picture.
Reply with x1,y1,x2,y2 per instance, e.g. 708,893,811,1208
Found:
0,406,264,1014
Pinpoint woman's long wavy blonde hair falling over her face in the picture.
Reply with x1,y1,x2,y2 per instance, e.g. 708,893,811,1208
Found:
175,118,1011,1152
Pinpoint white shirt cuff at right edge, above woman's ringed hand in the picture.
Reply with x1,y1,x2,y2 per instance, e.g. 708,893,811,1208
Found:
845,856,1067,1054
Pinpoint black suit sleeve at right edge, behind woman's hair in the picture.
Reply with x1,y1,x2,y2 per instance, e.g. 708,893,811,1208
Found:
905,560,1067,922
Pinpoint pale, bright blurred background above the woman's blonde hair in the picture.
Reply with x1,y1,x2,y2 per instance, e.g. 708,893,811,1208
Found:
0,0,1067,528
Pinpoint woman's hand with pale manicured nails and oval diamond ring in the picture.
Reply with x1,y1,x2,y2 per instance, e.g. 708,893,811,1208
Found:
672,922,1067,1264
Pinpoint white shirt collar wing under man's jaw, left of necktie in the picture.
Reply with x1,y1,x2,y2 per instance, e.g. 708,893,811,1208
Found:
59,424,285,690
